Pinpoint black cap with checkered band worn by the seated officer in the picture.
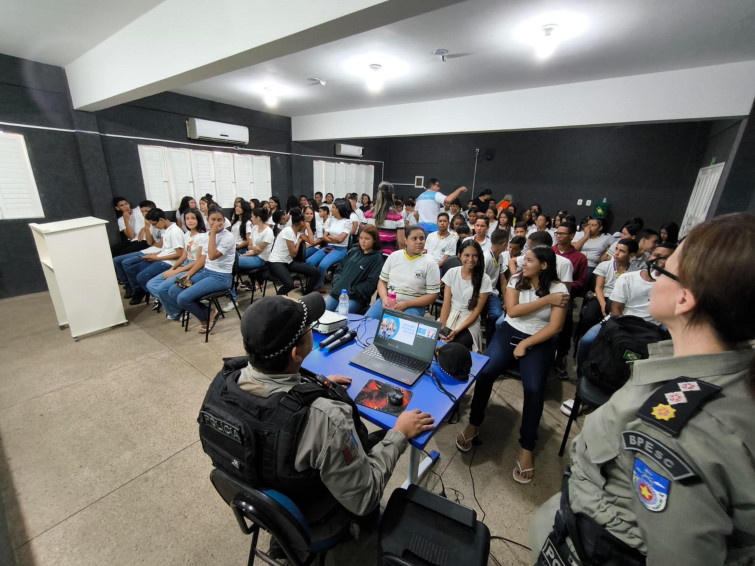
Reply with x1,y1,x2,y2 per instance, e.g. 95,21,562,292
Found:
241,293,325,358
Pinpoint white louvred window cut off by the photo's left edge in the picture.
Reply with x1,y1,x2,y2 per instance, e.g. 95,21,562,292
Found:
0,133,45,218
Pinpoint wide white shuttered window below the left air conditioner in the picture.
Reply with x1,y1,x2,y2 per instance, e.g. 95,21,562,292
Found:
139,145,272,210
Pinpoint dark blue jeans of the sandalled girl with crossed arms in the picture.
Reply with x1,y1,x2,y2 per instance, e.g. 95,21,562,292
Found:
469,322,556,450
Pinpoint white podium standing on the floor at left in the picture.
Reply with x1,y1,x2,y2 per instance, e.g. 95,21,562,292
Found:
29,216,128,341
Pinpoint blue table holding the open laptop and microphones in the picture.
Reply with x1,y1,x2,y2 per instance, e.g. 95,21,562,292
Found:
302,314,488,485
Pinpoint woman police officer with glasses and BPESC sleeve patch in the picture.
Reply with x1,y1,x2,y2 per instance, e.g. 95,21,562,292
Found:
530,213,755,566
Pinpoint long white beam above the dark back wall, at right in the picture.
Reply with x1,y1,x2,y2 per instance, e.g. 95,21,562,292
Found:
291,61,755,141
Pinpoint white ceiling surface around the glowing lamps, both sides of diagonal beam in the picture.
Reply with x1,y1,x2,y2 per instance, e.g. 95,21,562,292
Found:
0,0,755,117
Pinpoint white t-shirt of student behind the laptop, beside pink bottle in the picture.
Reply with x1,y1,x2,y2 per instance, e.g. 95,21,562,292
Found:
380,250,440,301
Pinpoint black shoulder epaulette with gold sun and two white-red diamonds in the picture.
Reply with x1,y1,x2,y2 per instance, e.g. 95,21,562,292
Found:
637,377,721,436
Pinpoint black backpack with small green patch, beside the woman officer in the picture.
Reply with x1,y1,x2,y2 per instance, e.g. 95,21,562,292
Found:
582,315,671,395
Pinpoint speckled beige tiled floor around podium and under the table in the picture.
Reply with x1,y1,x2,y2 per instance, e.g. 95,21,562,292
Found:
0,293,579,566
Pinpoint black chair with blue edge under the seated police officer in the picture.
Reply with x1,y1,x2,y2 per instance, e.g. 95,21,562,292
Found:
210,468,348,566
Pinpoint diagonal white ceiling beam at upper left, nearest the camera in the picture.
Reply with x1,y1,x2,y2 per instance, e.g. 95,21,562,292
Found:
66,0,460,111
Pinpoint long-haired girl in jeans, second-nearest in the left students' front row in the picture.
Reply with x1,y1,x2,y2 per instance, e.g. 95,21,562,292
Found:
147,208,208,320
